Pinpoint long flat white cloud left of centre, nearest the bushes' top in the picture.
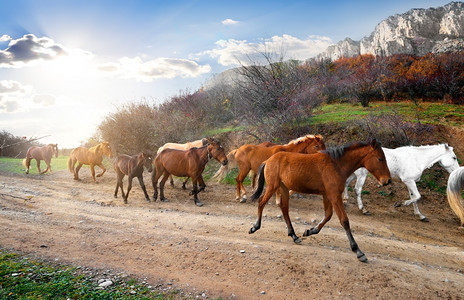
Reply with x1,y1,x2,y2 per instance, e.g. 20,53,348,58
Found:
98,57,211,82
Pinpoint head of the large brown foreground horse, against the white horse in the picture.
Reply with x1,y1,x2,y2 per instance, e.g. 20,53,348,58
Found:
364,139,391,185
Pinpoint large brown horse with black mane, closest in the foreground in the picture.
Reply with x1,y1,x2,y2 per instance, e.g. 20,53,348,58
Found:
249,139,391,262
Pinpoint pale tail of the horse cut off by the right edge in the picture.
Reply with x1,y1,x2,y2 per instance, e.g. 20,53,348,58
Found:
446,167,464,227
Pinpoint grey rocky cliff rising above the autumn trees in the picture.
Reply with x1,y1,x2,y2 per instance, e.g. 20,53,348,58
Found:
317,2,464,60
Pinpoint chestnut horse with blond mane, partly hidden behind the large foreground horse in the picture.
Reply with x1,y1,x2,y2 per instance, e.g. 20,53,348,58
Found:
235,134,325,203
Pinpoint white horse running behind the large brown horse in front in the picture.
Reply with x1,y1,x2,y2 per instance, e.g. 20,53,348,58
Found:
343,144,459,222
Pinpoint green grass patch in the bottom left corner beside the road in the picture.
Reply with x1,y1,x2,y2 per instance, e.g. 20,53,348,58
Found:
0,251,183,299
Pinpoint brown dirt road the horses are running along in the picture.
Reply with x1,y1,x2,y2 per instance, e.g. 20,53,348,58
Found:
0,169,464,299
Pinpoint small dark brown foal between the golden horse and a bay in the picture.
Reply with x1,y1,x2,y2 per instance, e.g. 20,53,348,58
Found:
113,152,153,203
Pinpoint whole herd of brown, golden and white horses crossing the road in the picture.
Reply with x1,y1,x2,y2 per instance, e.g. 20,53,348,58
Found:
23,135,464,262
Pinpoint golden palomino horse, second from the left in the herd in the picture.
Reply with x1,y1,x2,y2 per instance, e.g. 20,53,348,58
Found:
68,142,113,182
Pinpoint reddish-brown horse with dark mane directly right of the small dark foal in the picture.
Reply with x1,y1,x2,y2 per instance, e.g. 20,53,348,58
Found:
152,139,227,206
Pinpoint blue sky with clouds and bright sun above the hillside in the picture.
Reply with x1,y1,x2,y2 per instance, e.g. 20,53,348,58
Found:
0,0,451,148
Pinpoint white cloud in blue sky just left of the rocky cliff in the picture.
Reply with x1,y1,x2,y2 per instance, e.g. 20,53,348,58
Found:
198,34,333,66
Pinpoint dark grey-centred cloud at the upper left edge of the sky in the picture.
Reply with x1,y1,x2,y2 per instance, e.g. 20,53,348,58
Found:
0,34,67,68
